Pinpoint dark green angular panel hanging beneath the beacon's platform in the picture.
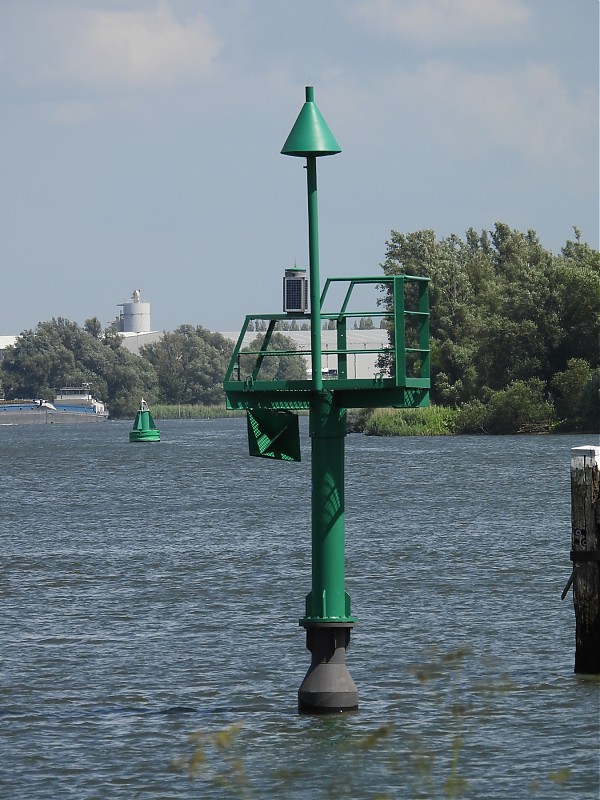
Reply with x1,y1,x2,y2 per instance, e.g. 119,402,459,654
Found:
246,409,301,461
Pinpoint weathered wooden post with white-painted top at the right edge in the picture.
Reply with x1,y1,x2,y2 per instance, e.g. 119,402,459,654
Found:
571,446,600,675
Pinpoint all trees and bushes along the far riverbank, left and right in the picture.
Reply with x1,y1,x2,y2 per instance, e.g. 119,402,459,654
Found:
0,223,600,435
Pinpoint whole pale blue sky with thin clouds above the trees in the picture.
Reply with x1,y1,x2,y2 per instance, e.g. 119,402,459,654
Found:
0,0,599,335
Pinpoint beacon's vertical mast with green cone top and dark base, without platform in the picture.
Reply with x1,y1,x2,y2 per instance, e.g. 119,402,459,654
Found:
281,86,358,713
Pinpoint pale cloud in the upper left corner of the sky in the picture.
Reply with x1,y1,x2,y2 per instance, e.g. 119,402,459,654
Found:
5,2,221,88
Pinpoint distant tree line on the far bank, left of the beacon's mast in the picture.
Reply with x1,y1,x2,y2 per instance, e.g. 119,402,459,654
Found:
0,317,306,418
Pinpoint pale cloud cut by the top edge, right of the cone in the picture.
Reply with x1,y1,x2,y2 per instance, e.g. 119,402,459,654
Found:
353,0,530,46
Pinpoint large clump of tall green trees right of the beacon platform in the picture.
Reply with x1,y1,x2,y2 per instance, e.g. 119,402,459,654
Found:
380,223,600,432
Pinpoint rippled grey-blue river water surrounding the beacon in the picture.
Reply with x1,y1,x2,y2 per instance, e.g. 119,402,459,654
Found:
0,418,600,800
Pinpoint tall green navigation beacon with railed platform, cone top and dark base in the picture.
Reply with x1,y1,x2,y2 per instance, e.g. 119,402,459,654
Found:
224,86,430,714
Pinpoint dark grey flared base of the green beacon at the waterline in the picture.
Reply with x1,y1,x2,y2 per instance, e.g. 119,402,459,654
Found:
298,623,358,714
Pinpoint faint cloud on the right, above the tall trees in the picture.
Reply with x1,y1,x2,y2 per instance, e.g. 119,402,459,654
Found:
376,60,598,170
